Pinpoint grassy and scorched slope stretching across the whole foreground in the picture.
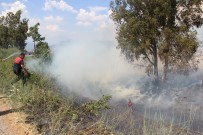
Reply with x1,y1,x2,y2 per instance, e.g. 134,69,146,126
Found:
0,49,202,135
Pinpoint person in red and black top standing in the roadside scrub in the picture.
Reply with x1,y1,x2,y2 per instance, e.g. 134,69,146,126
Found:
11,53,30,86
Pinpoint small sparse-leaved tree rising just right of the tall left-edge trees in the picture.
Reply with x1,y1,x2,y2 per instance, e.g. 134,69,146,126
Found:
28,23,45,50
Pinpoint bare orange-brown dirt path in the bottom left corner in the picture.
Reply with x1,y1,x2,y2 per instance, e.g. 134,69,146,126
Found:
0,95,39,135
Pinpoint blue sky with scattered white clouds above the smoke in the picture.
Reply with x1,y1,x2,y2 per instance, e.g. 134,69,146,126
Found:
0,0,116,50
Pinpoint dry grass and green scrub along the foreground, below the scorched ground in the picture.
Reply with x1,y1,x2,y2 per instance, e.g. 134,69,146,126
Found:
0,49,202,135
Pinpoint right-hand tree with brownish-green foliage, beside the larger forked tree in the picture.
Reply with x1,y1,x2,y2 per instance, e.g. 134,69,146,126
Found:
159,0,203,81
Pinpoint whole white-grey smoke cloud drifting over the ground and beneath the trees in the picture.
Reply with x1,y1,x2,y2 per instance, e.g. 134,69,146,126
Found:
28,42,203,112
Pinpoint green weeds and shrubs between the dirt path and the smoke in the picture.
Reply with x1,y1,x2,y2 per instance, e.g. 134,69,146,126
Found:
0,49,110,134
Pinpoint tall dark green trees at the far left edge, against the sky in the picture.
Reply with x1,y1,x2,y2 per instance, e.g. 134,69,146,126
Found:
0,10,28,51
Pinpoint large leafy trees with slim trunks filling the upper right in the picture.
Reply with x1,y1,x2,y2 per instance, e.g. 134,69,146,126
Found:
110,0,202,83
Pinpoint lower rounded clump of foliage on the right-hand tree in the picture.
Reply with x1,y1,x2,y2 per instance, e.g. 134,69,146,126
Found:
159,27,199,74
